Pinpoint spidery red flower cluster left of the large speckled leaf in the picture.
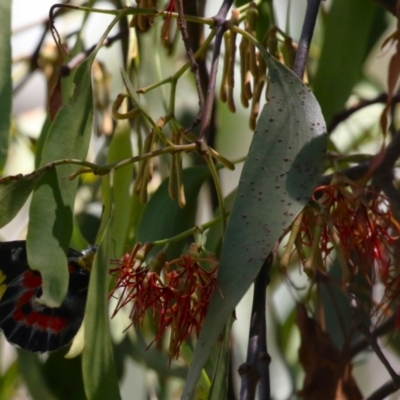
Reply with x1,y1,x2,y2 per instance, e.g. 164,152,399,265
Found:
110,244,218,358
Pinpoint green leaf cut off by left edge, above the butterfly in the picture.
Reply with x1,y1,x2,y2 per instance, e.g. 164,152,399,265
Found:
0,170,46,228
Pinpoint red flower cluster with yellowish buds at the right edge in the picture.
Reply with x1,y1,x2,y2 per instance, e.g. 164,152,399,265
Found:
285,179,400,318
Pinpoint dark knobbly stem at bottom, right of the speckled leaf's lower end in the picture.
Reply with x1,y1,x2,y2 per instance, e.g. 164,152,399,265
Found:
239,253,273,400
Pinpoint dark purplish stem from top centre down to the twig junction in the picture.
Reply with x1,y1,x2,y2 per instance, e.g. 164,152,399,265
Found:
199,0,233,146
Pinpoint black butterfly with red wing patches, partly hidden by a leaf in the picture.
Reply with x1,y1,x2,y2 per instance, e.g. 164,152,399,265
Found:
0,240,96,353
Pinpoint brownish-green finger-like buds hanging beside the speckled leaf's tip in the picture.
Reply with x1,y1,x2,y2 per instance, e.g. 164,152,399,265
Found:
220,2,296,130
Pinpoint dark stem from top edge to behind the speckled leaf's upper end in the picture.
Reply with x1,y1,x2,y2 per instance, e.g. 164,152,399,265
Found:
293,0,321,79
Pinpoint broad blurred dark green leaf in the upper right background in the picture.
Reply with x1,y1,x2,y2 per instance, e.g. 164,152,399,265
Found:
312,0,385,122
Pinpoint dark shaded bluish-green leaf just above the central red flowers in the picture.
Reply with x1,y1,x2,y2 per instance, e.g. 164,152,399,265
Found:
137,167,210,259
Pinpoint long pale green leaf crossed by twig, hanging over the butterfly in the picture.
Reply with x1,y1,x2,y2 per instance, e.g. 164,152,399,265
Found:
27,57,93,306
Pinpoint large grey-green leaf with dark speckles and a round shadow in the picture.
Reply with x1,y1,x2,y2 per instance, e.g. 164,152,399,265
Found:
183,47,326,400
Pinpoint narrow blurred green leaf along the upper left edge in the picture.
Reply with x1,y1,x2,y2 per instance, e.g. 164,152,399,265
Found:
0,1,12,173
